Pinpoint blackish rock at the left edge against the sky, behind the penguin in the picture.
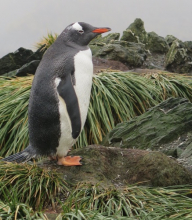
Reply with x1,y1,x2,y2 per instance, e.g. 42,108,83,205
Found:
0,47,33,75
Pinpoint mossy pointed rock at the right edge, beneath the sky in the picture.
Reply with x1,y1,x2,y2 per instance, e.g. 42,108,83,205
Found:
165,40,192,73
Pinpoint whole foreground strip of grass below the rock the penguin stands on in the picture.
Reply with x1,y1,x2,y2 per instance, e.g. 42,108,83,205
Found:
0,163,192,217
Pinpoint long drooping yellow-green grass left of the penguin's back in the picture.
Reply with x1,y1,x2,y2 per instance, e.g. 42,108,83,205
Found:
0,77,32,156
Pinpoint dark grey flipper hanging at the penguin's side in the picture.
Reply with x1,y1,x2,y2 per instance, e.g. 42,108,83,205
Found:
57,74,81,139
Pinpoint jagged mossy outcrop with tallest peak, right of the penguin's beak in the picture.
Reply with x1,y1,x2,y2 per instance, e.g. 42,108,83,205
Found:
90,19,169,69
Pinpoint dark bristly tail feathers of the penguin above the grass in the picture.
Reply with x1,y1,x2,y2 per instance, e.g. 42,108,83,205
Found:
2,145,36,163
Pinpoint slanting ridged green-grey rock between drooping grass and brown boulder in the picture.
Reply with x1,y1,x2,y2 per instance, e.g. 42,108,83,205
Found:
102,98,192,160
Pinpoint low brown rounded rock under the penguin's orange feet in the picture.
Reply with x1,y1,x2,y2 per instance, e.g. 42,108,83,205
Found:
42,145,192,186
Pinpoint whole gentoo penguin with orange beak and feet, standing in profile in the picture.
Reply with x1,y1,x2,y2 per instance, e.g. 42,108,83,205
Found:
4,22,111,166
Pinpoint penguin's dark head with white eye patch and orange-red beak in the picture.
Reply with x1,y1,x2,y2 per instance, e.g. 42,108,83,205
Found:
63,22,111,46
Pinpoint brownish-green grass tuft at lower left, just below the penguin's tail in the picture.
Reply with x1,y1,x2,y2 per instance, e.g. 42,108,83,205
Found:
0,162,68,210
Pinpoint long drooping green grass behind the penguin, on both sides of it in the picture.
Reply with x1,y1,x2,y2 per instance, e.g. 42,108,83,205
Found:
0,72,192,156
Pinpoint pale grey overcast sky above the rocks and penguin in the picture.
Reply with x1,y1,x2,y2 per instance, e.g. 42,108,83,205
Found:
0,0,192,57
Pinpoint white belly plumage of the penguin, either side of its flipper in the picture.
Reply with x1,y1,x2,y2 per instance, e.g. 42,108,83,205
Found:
55,49,93,156
